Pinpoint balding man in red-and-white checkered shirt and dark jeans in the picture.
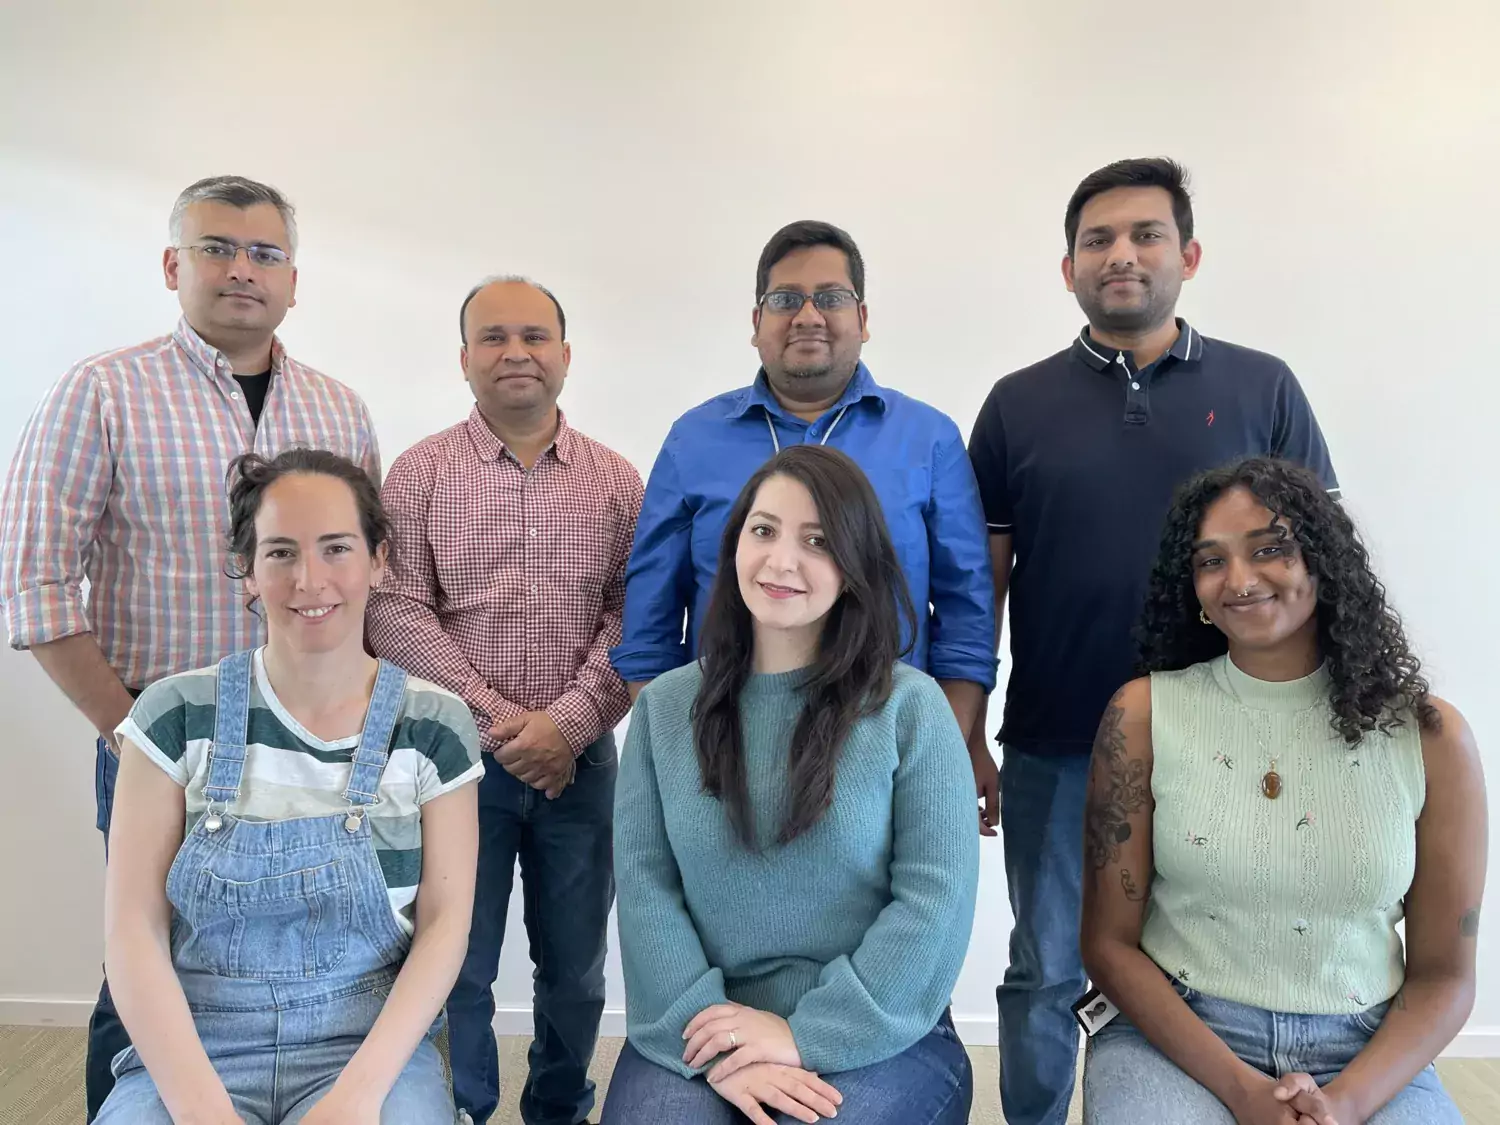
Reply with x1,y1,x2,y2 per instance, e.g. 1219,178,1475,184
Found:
368,278,642,1125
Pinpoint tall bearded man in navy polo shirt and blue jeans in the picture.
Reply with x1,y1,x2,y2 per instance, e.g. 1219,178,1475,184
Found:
969,159,1338,1125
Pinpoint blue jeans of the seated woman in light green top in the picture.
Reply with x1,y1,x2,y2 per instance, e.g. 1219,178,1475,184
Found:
1083,981,1464,1125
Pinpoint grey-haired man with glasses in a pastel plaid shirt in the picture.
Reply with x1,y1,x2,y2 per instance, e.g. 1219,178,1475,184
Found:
0,176,380,1121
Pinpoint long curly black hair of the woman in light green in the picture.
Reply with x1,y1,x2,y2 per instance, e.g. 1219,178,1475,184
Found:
1136,458,1439,746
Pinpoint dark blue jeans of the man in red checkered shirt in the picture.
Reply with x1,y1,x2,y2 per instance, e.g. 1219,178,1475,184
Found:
449,734,620,1125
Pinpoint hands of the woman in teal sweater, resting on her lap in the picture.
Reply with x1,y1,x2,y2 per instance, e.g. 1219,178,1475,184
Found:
683,1004,846,1125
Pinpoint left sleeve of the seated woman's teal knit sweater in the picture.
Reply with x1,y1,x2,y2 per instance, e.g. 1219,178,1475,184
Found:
615,687,726,1077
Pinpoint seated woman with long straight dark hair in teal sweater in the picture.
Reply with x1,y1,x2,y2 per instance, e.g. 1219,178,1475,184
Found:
603,446,980,1125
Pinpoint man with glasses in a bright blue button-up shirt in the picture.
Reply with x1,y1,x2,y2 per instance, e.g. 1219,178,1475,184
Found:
611,222,998,798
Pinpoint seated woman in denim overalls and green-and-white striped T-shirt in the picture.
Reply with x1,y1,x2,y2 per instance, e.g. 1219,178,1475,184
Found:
98,450,477,1125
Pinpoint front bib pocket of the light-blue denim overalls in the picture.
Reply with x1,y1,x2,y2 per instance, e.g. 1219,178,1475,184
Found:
177,860,354,981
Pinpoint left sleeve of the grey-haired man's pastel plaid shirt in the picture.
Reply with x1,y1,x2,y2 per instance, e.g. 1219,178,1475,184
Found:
0,365,114,648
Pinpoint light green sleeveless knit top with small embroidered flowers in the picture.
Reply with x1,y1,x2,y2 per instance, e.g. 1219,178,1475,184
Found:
1140,656,1427,1014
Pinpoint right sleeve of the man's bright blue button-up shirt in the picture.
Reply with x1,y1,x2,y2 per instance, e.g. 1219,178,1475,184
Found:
926,423,996,692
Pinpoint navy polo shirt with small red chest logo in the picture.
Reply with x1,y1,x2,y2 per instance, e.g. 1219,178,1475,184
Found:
969,320,1338,755
